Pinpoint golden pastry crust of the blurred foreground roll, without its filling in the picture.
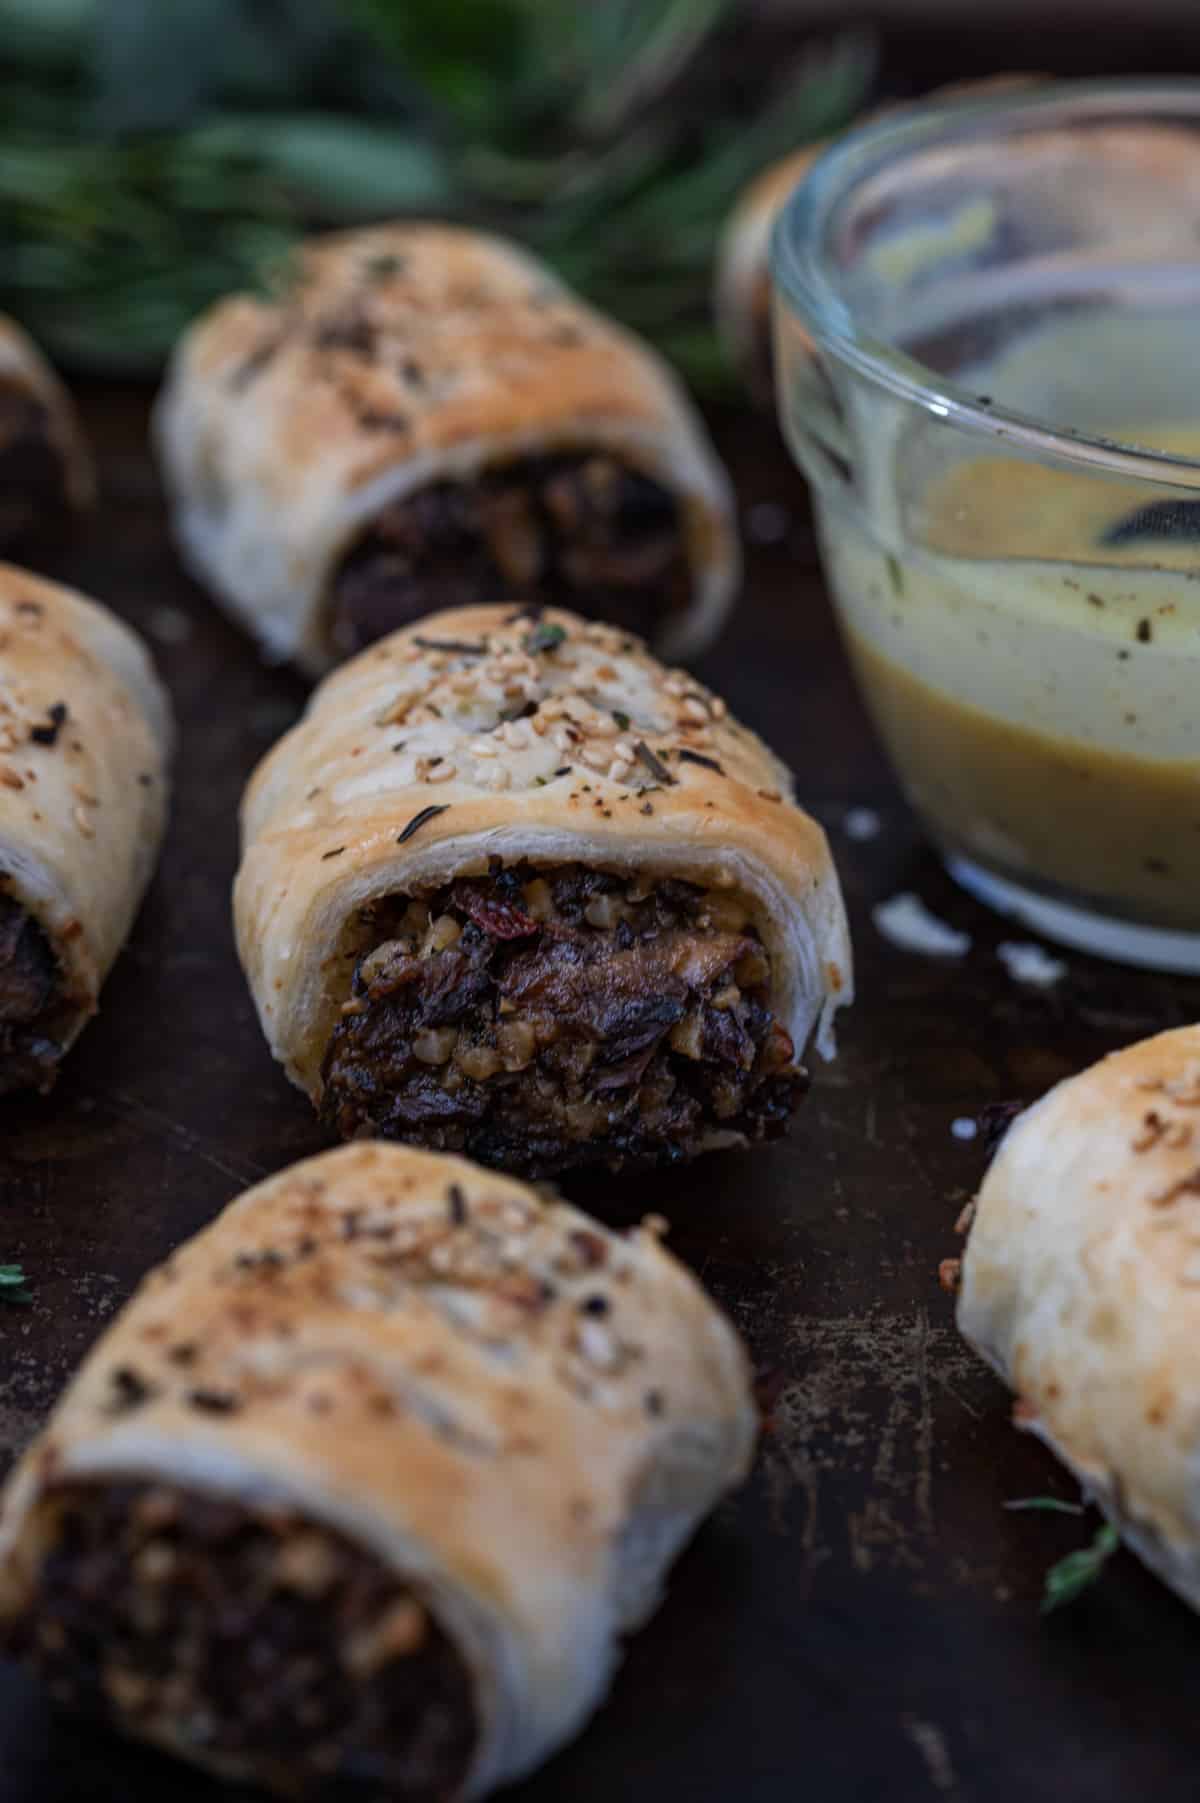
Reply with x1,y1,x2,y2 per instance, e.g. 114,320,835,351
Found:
0,1145,755,1796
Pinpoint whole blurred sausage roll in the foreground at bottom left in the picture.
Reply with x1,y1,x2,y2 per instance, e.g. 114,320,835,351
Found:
0,1145,757,1803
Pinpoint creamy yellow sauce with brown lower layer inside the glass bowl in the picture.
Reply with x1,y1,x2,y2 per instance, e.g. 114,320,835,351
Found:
822,376,1200,915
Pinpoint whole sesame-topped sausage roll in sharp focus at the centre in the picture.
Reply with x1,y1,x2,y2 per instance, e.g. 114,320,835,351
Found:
234,608,850,1174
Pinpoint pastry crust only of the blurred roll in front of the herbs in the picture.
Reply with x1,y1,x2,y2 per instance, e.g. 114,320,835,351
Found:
157,225,739,671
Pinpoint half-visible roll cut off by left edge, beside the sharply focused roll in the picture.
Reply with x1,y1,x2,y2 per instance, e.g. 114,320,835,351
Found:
0,564,171,1094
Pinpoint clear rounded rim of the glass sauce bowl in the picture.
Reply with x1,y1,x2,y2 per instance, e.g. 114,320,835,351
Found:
771,78,1200,490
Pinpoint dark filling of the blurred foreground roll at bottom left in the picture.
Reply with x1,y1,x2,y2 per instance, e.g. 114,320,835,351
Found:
13,1482,477,1803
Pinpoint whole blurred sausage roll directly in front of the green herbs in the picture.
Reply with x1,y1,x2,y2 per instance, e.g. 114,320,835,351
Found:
159,225,739,671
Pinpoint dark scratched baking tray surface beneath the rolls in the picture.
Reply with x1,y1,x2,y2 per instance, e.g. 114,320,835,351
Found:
0,388,1200,1803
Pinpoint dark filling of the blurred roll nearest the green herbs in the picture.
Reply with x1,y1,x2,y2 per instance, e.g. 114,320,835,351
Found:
330,453,692,654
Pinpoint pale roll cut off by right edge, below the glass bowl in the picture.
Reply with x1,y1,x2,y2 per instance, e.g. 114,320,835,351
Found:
959,1026,1200,1608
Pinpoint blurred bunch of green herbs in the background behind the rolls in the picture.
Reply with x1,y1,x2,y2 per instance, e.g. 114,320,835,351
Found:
0,0,872,384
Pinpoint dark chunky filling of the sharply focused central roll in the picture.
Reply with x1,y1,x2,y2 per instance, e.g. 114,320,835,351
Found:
323,858,807,1176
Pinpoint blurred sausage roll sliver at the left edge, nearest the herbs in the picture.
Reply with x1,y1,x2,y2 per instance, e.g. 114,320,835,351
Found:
0,314,95,550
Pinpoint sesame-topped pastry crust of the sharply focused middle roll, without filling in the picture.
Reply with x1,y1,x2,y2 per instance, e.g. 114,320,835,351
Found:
234,606,852,1103
